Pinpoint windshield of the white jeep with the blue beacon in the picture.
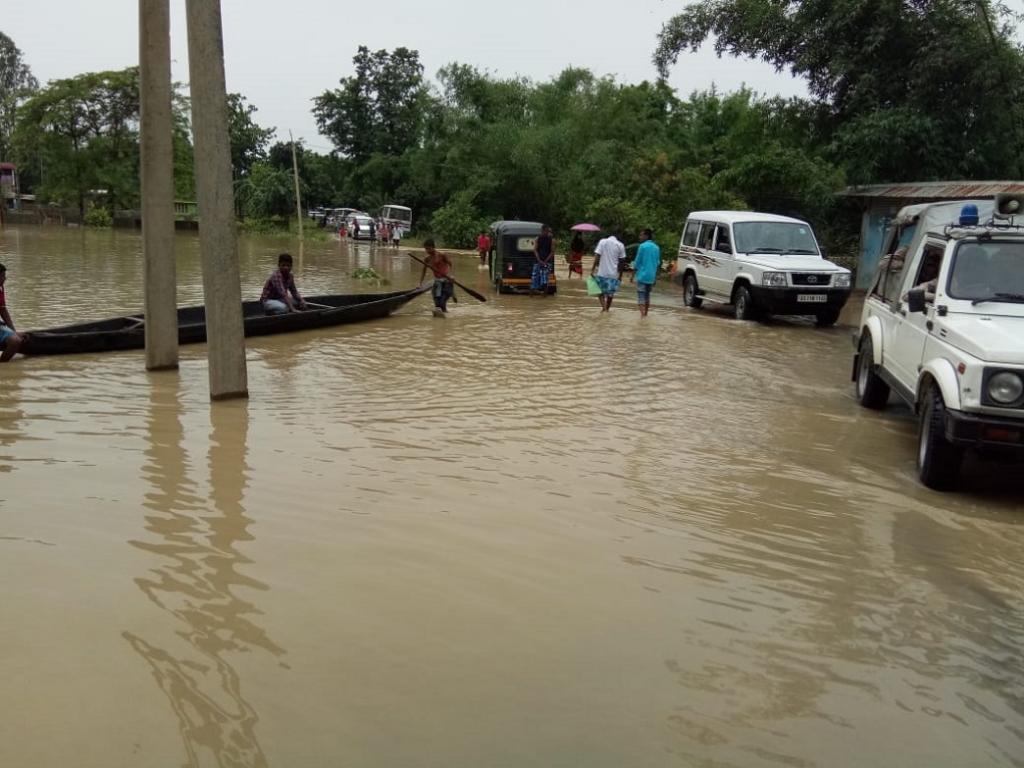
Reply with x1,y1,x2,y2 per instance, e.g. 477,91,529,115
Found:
946,241,1024,305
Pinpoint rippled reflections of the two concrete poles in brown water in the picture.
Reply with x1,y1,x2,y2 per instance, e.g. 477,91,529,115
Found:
124,382,285,767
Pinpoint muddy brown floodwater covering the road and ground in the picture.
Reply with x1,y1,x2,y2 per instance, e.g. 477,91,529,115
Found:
0,228,1024,768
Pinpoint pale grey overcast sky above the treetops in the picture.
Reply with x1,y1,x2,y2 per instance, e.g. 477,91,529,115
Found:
6,0,1024,152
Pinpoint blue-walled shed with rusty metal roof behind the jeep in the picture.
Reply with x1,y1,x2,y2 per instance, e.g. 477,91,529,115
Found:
840,181,1024,289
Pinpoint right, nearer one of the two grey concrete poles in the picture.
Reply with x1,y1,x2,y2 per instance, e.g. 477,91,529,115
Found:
185,0,249,400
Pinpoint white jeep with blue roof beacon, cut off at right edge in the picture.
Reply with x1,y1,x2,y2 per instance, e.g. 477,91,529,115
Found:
853,199,1024,489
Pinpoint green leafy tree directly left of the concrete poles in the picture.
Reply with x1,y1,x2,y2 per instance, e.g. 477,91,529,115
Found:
12,68,138,215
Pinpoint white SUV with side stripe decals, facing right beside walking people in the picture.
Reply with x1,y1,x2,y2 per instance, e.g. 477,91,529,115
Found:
675,211,850,326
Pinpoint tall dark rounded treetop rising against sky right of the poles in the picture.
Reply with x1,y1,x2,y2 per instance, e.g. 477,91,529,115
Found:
313,46,428,163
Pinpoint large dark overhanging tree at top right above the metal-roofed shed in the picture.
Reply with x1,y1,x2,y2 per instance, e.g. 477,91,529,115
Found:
654,0,1024,182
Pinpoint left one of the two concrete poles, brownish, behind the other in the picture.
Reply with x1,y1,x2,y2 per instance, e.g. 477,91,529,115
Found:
138,0,178,371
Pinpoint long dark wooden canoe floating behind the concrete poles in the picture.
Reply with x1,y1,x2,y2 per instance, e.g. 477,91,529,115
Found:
22,284,430,355
